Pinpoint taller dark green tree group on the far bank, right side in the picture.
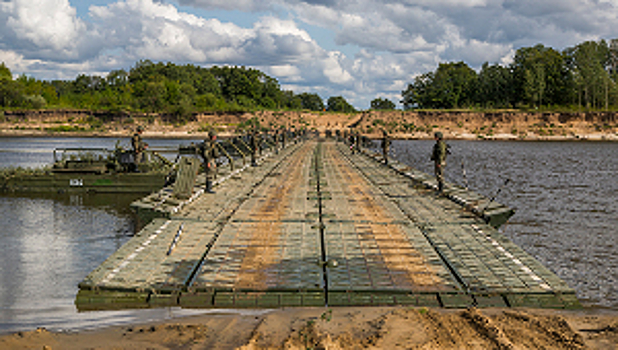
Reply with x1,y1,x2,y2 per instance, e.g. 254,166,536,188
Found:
401,39,618,110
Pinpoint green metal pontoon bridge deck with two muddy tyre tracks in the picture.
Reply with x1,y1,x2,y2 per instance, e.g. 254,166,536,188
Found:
77,141,578,309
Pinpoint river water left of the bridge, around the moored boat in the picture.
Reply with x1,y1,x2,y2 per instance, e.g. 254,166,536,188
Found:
0,138,202,333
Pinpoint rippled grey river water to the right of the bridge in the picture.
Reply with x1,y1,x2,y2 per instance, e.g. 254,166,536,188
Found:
393,141,618,310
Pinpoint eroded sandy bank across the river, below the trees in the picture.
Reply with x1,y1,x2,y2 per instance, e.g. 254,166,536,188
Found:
0,110,618,141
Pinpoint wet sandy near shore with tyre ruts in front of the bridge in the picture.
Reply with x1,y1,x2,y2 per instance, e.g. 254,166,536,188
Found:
0,307,618,349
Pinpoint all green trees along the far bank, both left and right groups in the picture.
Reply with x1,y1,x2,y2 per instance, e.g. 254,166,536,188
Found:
0,39,618,114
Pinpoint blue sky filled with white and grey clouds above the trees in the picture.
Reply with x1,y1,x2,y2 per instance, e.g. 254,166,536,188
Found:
0,0,618,109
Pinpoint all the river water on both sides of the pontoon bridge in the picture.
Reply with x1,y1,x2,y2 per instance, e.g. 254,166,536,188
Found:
0,138,618,334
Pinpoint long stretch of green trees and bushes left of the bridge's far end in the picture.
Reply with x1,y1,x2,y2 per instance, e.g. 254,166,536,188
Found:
0,60,355,118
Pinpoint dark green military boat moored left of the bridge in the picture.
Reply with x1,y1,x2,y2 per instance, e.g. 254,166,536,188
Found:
0,147,174,193
